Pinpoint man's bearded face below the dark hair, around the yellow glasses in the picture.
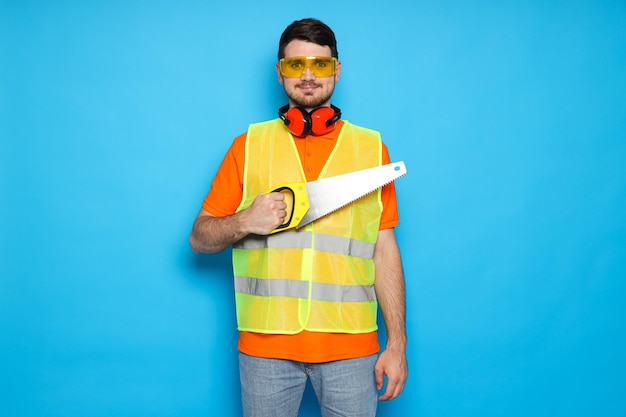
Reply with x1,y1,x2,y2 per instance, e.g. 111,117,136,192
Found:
276,40,341,111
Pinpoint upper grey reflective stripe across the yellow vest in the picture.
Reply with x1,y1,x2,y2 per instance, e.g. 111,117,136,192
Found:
233,230,376,259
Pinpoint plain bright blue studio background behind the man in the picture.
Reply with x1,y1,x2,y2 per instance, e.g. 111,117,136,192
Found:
0,0,626,417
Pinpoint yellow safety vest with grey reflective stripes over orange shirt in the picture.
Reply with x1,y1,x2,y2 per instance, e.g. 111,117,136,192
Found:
233,119,382,334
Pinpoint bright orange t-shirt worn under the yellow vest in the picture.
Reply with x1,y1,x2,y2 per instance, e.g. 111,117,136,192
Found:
202,121,399,363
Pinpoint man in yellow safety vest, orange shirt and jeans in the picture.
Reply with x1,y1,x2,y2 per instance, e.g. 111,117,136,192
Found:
190,19,408,417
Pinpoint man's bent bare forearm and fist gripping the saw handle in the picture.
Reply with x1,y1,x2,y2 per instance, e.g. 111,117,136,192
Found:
189,193,287,253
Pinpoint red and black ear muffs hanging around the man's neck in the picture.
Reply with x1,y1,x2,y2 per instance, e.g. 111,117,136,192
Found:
278,105,341,137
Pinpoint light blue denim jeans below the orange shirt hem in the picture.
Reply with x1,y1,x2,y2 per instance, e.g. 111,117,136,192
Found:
239,353,378,417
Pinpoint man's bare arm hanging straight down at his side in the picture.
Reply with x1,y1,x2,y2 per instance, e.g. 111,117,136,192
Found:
374,229,408,400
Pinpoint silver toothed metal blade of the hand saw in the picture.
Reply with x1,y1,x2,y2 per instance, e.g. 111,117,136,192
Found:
296,161,406,229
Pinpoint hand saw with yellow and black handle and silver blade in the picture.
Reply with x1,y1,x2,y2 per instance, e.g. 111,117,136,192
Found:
268,161,406,233
